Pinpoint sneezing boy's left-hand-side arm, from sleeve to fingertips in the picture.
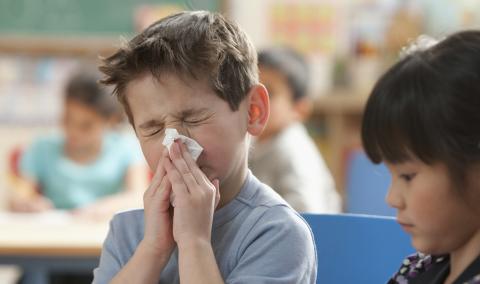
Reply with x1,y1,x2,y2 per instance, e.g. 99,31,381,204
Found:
94,151,175,283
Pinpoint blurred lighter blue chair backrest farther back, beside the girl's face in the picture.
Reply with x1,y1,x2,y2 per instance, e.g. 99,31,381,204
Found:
345,150,395,216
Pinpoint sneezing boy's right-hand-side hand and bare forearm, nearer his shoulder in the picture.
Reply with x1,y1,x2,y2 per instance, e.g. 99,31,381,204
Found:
165,141,224,284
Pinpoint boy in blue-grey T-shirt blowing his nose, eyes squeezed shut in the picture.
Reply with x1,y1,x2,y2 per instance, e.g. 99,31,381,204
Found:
94,11,316,284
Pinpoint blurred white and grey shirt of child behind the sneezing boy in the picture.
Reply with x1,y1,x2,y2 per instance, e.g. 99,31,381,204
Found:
249,123,341,213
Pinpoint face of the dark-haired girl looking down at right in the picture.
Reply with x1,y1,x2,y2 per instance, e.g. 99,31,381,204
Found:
386,160,480,254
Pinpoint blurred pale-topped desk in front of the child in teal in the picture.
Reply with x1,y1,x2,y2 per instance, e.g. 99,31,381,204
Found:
0,212,108,284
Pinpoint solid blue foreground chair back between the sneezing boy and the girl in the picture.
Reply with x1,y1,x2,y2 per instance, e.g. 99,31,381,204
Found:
302,214,415,284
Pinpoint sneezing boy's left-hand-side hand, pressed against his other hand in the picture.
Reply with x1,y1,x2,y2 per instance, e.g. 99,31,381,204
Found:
142,149,175,260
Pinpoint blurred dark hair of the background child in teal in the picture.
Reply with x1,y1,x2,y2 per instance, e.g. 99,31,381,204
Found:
65,69,121,118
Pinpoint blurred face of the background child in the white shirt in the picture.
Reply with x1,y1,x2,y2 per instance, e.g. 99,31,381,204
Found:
259,66,299,142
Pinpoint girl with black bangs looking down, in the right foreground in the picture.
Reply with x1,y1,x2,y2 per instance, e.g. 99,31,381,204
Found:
362,31,480,284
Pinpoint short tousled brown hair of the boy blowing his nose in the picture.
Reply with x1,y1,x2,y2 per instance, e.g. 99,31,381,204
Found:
99,11,258,126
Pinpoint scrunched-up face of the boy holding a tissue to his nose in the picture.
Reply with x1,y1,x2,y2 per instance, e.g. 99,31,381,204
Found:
126,74,248,184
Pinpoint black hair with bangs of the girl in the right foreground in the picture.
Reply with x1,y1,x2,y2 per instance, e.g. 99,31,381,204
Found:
362,31,480,184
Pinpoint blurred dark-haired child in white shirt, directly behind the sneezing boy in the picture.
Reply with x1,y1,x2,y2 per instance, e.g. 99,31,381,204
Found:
250,48,340,213
